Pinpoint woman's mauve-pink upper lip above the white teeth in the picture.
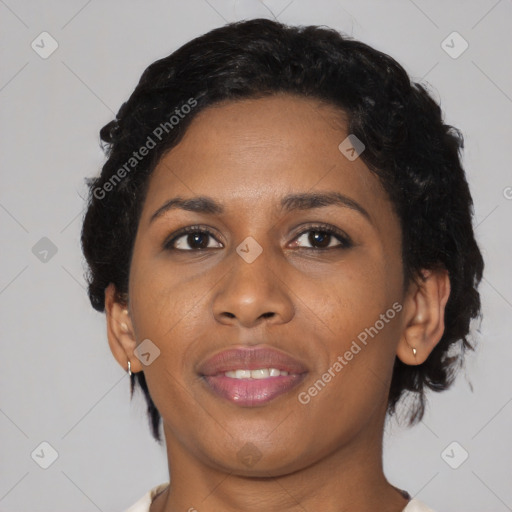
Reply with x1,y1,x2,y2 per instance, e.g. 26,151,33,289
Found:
199,346,307,376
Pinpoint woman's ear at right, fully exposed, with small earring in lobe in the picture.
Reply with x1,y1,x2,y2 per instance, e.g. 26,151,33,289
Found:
397,269,450,365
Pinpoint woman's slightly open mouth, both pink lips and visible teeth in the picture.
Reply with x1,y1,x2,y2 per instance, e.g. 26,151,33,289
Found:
198,346,308,407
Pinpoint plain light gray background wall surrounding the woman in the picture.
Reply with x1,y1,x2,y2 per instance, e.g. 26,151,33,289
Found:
0,0,512,512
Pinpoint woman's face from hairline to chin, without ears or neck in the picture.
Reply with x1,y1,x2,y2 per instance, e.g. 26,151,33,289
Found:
123,95,403,476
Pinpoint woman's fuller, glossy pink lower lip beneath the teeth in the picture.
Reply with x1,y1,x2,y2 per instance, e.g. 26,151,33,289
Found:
203,373,306,407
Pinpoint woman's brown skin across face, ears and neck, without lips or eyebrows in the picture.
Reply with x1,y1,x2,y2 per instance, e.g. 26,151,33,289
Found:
105,95,450,512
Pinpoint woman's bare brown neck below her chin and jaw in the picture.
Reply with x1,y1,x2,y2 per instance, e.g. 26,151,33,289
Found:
150,412,407,512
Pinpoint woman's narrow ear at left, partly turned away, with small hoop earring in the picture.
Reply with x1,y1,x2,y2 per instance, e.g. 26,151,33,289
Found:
105,283,142,373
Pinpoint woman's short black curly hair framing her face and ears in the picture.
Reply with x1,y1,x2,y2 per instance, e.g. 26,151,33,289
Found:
81,19,484,442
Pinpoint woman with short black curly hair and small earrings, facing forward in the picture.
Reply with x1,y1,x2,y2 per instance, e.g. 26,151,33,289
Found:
82,19,483,512
